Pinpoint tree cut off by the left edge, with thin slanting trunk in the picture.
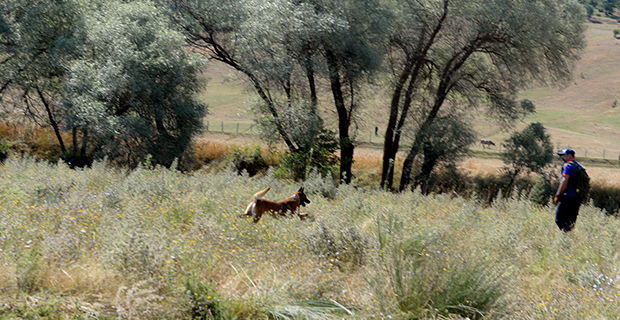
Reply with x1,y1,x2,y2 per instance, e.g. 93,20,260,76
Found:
0,0,84,152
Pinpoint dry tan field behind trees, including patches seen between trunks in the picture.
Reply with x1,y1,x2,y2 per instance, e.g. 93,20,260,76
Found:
201,18,620,160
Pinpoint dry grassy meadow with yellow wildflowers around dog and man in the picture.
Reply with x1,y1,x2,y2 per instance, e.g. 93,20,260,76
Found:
0,157,620,319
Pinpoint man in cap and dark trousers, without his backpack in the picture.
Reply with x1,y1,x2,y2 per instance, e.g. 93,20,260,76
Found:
553,148,581,232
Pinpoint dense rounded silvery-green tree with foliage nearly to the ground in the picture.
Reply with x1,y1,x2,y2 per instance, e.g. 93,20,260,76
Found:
63,0,206,166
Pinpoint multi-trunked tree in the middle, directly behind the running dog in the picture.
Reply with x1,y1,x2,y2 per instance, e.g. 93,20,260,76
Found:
169,0,386,182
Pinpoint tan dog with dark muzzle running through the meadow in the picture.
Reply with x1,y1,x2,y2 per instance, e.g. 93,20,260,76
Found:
240,187,310,223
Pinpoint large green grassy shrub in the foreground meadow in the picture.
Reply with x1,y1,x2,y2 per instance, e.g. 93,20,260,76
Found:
378,211,508,319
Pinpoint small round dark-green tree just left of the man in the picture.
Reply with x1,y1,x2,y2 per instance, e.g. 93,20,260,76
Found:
502,122,553,192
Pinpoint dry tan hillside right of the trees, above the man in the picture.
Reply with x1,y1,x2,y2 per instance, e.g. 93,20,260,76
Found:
477,20,620,159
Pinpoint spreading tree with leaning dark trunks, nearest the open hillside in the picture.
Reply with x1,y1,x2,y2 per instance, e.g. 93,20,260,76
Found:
382,0,585,190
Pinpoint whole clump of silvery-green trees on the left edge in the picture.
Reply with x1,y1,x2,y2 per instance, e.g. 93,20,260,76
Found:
0,0,206,167
